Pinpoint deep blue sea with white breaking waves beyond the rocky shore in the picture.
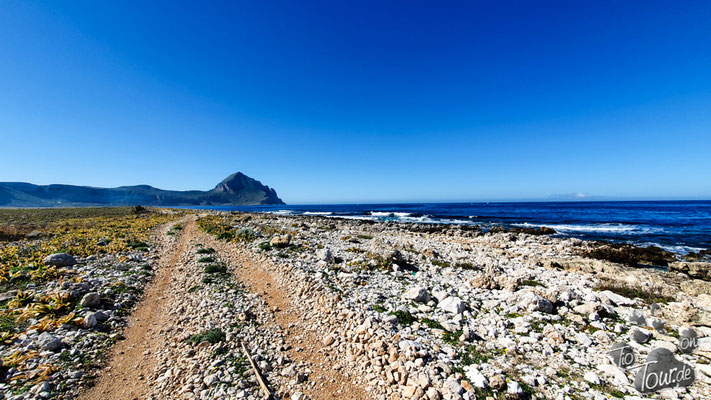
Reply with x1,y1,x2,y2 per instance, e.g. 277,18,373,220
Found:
188,201,711,253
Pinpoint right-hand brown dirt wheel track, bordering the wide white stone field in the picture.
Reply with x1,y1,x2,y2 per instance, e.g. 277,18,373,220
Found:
200,232,371,400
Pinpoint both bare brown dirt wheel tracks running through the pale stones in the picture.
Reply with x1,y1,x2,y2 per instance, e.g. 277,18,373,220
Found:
80,216,371,400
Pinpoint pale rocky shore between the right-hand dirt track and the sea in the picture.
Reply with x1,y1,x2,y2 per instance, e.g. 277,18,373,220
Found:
192,214,711,399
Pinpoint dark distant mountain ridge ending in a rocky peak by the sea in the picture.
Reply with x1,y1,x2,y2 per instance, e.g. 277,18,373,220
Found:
0,172,284,207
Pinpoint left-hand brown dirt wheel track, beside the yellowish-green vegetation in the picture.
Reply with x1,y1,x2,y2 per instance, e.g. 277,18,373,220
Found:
79,216,195,400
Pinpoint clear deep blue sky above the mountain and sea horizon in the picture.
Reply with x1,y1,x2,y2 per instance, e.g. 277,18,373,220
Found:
0,0,711,203
